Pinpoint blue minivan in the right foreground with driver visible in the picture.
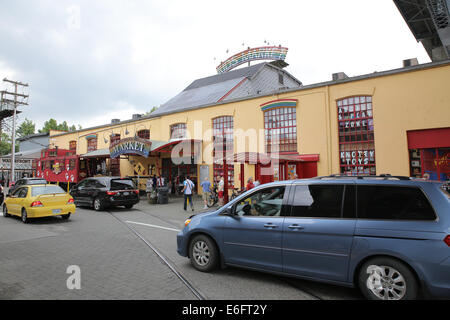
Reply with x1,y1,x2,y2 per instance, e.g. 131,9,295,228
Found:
177,175,450,300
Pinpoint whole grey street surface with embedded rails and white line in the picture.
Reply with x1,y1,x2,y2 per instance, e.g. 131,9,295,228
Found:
0,199,362,300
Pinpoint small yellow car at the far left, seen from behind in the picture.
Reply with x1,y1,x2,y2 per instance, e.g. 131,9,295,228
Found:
3,184,75,223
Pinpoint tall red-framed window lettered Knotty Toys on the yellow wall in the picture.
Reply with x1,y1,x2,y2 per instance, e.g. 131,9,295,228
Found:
337,96,376,175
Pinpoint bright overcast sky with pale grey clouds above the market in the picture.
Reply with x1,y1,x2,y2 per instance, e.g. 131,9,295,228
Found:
0,0,430,129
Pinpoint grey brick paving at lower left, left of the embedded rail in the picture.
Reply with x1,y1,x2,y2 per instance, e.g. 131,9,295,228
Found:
0,204,194,300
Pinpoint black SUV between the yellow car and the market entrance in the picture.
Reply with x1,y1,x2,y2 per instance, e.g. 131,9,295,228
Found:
70,177,139,211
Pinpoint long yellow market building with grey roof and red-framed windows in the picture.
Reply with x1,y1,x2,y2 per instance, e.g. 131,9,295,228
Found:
44,60,450,193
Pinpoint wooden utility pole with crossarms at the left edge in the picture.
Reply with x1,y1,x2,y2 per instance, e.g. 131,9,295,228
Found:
2,78,28,187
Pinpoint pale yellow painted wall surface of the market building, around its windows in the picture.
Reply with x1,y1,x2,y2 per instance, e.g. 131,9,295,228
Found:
51,64,450,186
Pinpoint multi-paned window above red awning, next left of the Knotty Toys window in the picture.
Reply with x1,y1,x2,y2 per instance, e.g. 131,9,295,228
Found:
264,107,297,153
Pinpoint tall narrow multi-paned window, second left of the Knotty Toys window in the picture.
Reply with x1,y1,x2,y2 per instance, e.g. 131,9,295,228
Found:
212,116,234,188
